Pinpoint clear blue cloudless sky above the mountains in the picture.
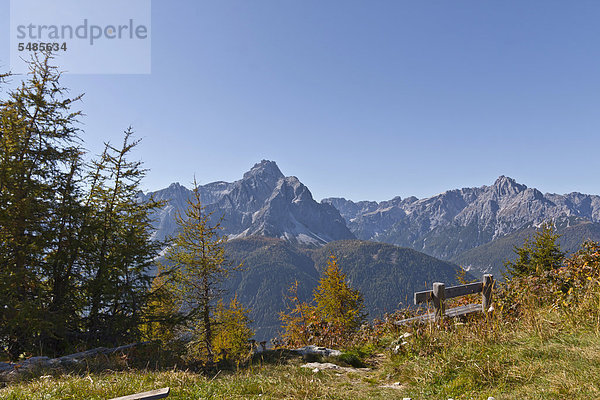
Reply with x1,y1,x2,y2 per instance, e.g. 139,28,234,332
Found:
0,0,600,200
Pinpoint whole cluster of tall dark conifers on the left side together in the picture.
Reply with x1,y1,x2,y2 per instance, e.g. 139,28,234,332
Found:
0,55,162,359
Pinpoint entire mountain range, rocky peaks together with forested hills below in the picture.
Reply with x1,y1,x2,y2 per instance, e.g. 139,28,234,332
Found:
139,160,600,339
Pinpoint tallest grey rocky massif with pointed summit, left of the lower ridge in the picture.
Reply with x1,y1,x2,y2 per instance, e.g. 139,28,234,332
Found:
142,160,354,245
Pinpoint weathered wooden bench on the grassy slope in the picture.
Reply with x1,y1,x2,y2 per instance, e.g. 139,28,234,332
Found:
396,274,494,325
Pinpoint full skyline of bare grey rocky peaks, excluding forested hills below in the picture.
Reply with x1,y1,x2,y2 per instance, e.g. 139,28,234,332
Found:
140,160,600,271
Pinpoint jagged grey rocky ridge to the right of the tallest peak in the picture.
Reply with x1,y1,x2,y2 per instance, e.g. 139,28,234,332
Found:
322,176,600,259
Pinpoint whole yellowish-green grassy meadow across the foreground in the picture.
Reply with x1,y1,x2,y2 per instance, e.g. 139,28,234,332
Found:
0,307,600,400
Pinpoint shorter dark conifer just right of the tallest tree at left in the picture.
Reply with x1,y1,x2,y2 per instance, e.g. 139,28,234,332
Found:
82,128,164,345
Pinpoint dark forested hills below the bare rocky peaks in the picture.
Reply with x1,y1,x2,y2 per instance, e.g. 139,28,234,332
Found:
225,236,462,340
